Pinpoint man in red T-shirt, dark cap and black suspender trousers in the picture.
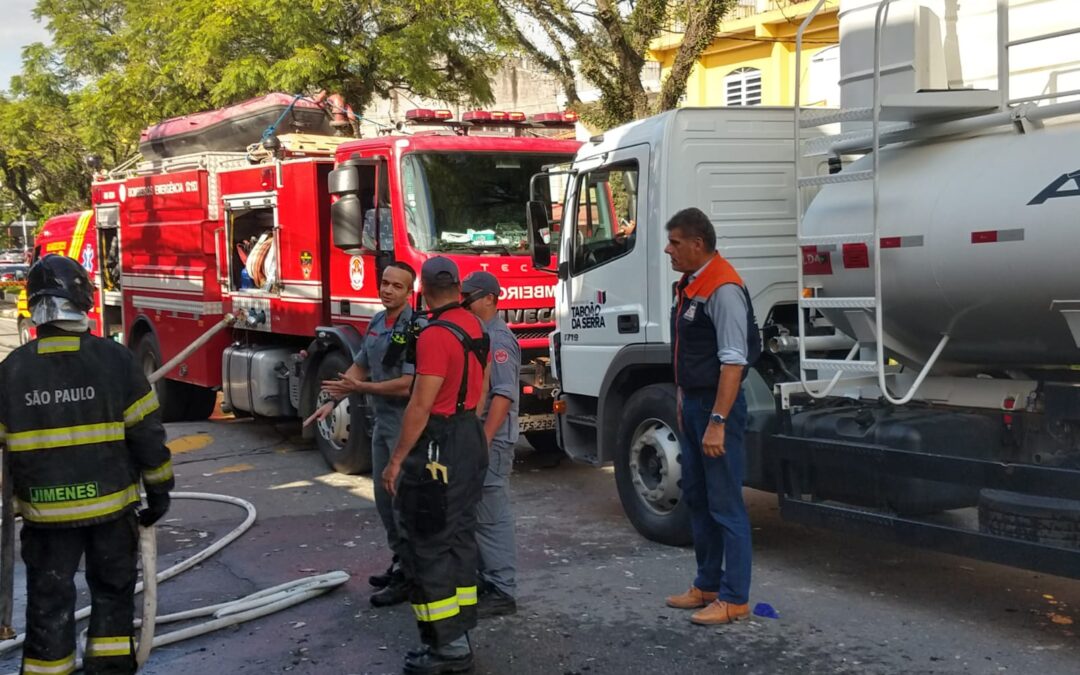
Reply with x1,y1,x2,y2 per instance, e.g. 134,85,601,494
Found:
382,256,488,673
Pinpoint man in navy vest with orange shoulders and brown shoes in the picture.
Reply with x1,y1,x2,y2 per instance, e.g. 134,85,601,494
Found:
664,208,761,625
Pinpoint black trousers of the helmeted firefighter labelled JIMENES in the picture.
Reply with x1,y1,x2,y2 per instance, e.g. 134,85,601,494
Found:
21,511,138,675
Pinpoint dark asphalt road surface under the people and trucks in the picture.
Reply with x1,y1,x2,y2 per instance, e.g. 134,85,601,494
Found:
0,322,1080,675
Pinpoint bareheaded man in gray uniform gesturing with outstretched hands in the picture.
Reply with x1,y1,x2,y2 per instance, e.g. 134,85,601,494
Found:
305,262,416,607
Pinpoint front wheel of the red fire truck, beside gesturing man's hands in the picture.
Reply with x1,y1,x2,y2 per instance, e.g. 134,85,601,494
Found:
315,351,378,477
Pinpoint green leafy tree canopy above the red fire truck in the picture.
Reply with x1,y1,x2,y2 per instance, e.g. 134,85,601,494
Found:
0,0,500,216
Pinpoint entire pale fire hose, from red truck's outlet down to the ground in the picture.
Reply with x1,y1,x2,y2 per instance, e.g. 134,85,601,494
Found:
0,314,349,669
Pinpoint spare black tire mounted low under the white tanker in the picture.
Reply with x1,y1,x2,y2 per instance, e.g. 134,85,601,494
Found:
978,489,1080,550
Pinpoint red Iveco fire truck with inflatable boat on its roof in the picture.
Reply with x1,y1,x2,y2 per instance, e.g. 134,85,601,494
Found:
93,97,580,473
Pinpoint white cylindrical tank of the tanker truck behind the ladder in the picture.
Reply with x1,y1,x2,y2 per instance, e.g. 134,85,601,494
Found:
802,123,1080,373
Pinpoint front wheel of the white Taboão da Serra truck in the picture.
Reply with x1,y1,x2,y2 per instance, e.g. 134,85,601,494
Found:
615,384,691,546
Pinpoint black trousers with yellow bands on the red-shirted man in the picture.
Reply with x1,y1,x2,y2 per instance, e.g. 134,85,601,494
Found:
395,410,487,648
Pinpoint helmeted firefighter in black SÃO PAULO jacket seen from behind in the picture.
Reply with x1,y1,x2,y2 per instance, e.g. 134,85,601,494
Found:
0,255,174,675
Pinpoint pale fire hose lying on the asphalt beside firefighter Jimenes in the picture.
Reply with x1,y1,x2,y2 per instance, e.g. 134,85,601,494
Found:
0,492,349,667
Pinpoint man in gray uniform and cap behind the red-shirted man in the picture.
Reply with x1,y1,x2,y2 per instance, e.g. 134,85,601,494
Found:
461,272,522,618
